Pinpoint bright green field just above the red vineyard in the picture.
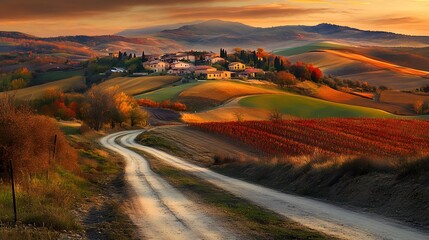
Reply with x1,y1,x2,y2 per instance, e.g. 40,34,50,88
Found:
239,94,395,118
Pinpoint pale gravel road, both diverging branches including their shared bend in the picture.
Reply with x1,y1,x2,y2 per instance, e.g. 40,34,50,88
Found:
101,131,429,240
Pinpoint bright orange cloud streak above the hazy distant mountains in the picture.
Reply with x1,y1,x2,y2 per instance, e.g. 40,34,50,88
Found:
162,4,329,19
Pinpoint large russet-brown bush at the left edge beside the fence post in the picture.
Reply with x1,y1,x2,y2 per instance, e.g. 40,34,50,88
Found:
0,96,78,177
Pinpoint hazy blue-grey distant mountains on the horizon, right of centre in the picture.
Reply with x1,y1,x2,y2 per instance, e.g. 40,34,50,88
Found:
132,20,429,50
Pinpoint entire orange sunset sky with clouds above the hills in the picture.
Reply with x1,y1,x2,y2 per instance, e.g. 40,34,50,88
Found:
0,0,429,37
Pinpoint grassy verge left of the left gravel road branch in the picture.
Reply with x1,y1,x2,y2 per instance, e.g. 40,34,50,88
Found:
0,126,138,240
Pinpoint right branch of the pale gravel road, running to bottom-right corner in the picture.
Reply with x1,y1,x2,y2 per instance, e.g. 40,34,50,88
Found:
121,130,429,240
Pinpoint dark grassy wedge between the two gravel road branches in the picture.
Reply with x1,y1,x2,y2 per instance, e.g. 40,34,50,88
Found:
133,149,333,239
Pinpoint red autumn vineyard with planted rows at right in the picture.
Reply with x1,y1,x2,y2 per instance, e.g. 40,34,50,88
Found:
193,119,429,157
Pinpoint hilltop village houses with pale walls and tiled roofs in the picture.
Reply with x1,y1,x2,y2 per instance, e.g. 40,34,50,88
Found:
109,51,265,80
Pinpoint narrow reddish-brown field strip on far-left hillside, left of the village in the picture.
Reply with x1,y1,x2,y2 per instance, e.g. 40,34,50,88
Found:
0,76,85,101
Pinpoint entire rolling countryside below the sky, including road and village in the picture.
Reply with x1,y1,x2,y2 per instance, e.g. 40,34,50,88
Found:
0,17,429,240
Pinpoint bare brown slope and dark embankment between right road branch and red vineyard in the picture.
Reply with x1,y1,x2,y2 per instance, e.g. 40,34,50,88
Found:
148,126,429,229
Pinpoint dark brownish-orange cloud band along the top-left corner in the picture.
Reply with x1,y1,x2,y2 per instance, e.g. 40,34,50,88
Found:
0,0,236,20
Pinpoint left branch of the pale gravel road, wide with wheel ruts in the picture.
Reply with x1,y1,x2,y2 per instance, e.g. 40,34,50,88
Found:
100,131,235,239
